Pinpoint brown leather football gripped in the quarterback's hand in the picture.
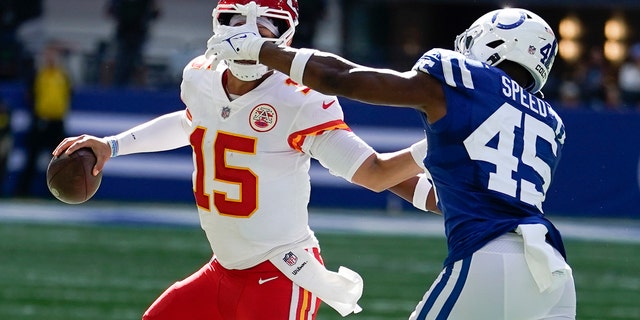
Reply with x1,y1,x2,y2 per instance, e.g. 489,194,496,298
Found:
47,148,102,204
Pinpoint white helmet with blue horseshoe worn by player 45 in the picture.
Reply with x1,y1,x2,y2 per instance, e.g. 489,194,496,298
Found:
455,8,558,93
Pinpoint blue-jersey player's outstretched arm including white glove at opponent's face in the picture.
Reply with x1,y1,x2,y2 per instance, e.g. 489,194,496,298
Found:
206,17,446,122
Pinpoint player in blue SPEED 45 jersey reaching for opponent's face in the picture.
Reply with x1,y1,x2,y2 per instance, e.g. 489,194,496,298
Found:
207,8,576,320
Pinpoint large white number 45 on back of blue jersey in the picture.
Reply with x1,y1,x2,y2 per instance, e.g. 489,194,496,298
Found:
464,103,558,211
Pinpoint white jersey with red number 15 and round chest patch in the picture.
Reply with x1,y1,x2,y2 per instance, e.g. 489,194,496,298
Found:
181,56,349,269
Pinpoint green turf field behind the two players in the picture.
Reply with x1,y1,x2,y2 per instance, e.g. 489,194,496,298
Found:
0,223,640,320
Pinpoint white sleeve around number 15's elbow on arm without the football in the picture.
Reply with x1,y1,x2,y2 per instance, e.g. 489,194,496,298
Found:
302,130,375,182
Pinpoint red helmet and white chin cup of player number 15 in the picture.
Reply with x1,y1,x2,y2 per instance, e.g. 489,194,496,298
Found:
212,0,298,81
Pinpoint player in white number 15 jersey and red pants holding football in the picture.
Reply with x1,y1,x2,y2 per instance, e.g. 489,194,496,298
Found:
54,0,435,320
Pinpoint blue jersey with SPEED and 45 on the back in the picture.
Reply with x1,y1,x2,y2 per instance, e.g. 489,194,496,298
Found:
414,49,566,265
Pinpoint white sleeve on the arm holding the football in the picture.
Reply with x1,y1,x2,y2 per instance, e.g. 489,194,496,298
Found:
107,110,189,155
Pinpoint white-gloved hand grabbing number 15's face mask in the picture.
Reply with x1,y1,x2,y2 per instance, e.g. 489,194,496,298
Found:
205,2,266,64
